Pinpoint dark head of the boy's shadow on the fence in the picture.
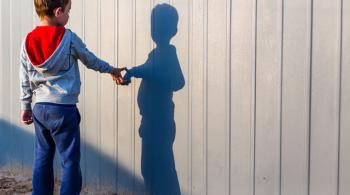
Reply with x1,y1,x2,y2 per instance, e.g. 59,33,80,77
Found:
151,3,179,44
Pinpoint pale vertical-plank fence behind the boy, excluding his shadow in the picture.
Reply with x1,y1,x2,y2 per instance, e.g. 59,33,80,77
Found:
0,0,350,195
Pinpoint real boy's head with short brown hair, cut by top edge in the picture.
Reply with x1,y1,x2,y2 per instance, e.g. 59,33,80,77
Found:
34,0,71,26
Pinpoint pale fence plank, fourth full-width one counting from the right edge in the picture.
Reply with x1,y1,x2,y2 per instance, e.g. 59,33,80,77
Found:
230,0,255,195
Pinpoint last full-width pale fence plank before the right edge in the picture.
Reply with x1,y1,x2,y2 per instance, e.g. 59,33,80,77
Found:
310,0,340,195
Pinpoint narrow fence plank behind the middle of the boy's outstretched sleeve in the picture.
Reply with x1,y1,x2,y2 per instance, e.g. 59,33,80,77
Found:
84,0,101,187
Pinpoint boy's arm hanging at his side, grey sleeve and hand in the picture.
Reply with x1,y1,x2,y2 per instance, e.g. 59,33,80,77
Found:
19,46,33,125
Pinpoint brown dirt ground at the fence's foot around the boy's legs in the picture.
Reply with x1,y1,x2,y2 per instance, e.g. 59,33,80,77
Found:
0,168,117,195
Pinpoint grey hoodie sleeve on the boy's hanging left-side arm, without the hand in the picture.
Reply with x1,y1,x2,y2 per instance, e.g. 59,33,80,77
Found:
19,44,33,110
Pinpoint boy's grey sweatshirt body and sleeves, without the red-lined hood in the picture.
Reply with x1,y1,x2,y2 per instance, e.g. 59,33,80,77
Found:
20,29,114,110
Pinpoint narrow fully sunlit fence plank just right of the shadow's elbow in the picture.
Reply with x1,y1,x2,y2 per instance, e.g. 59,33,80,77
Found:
187,1,206,195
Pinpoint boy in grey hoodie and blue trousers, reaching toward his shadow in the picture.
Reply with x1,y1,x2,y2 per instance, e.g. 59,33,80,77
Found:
20,0,124,195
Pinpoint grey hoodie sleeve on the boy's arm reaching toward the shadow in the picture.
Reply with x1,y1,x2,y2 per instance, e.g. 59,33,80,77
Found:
72,32,114,73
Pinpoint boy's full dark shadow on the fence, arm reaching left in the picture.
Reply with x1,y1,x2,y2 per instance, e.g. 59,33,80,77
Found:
124,4,185,194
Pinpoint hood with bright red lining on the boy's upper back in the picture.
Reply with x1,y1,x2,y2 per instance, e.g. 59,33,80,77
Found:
25,26,71,75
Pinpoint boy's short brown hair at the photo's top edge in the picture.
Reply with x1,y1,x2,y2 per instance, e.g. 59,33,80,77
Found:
34,0,70,18
